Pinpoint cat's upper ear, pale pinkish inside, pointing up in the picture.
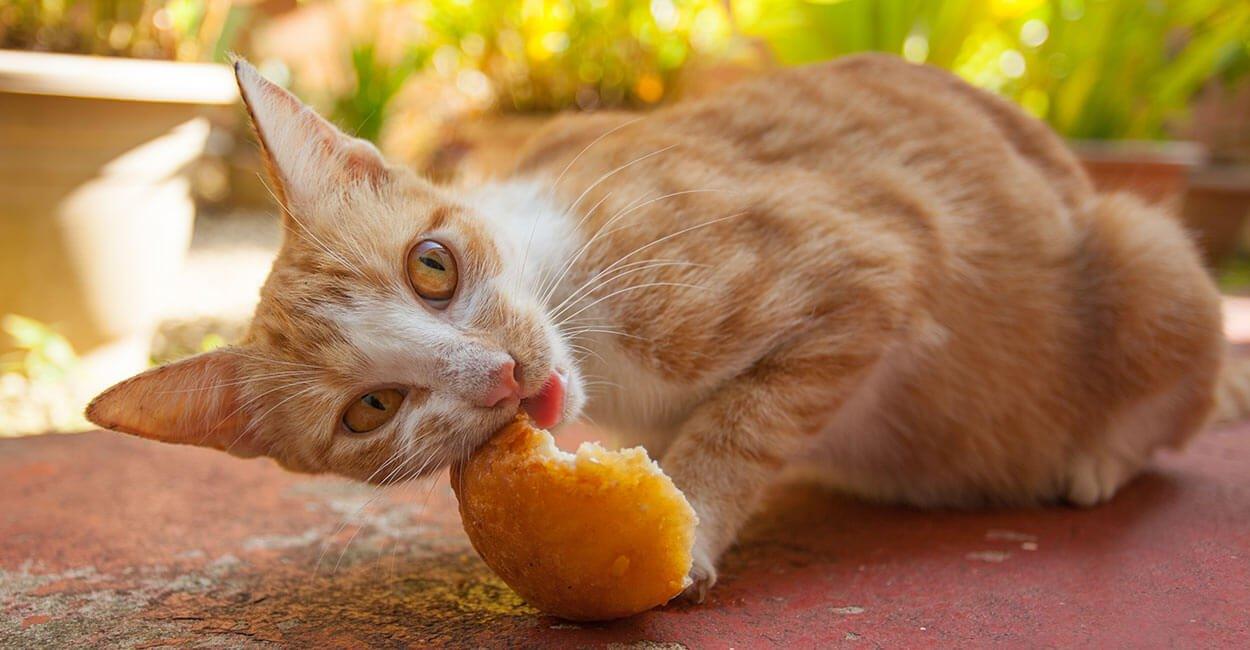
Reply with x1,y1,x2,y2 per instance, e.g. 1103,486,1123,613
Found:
234,59,388,209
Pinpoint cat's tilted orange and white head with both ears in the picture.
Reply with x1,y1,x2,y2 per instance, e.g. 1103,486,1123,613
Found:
88,63,584,483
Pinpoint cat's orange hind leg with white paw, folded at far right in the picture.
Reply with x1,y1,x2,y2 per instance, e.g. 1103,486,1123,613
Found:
1060,195,1225,506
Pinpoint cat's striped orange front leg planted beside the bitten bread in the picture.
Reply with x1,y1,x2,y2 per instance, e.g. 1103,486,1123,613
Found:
661,334,883,600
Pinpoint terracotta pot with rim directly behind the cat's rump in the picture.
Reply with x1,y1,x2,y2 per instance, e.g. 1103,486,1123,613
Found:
1071,140,1205,209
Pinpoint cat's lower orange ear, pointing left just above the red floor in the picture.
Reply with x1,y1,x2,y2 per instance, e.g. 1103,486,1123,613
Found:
86,350,264,458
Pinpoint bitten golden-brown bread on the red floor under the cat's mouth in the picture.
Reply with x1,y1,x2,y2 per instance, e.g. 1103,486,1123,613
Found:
451,415,698,620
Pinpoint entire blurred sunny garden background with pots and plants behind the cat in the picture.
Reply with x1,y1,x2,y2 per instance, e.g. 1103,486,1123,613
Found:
0,0,1250,436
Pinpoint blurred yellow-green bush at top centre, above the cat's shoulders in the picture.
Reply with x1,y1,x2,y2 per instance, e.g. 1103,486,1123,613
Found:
426,0,731,111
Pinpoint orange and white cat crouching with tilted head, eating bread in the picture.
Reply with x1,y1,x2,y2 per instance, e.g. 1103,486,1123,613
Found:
88,55,1246,599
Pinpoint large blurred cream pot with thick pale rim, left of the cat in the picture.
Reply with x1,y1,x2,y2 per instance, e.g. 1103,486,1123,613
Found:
0,51,236,400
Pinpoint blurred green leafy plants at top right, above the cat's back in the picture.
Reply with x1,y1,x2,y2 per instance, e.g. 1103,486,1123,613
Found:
733,0,1250,139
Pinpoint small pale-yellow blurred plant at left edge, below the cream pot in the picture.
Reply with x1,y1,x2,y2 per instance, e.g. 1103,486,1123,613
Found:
0,314,88,436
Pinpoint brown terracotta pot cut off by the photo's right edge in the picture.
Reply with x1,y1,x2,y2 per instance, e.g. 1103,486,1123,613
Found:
1183,165,1250,269
